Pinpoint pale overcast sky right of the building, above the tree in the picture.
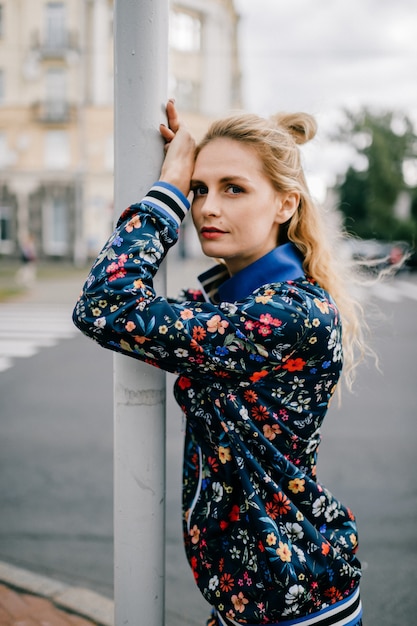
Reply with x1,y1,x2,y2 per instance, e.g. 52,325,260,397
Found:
235,0,417,194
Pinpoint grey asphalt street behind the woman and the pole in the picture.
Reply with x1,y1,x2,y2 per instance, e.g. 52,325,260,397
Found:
0,271,417,626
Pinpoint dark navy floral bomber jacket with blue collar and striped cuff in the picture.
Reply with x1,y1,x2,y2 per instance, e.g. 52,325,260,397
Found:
73,182,360,624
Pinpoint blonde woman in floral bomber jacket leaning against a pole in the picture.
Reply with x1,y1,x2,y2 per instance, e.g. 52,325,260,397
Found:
74,101,362,626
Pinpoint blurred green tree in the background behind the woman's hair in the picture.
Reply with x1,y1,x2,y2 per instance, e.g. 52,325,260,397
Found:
333,108,417,244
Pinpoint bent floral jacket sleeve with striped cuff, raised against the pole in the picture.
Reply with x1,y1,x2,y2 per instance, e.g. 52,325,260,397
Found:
73,183,328,382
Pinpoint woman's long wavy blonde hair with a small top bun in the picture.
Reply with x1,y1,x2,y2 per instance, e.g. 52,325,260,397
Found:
197,113,372,388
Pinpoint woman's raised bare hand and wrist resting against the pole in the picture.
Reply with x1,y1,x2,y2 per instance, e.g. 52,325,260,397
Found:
159,100,195,196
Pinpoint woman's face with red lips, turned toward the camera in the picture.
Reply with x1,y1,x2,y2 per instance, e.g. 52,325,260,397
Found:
191,138,298,274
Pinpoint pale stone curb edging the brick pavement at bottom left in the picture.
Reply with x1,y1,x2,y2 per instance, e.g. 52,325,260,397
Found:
0,561,114,626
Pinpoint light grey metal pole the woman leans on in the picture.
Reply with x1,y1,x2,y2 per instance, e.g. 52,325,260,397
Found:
114,0,168,626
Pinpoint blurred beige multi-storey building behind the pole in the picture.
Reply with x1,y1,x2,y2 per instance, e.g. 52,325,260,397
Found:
0,0,240,262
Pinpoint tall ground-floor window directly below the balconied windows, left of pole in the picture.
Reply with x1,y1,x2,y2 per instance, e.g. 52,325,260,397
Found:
43,196,69,256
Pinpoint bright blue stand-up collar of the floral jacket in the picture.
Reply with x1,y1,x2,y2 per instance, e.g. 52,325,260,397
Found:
198,243,305,303
